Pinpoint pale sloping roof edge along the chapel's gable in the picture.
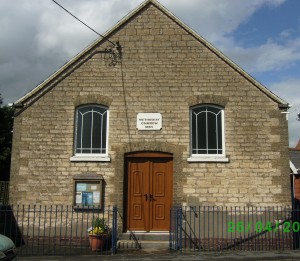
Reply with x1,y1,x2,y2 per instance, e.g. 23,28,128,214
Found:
14,0,289,110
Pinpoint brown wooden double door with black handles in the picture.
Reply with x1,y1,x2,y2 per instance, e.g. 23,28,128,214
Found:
126,153,173,231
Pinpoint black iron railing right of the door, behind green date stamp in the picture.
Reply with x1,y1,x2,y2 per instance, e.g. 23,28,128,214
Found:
170,206,300,251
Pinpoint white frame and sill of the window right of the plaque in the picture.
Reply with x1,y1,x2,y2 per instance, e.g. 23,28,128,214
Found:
187,104,229,162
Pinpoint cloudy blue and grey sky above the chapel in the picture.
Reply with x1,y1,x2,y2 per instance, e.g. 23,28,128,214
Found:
0,0,300,147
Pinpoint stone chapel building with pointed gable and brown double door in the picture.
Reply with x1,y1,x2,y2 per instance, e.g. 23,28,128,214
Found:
10,0,291,231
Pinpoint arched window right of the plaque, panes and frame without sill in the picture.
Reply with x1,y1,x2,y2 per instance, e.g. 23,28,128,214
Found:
190,104,225,156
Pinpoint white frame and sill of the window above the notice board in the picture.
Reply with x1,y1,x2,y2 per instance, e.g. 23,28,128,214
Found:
70,104,110,162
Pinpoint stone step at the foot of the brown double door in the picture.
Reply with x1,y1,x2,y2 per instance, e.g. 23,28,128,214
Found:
117,233,169,250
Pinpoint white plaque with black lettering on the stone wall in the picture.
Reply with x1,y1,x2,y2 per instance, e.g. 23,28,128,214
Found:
136,113,162,130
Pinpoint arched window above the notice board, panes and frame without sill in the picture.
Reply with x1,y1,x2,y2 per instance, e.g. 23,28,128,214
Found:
74,105,109,155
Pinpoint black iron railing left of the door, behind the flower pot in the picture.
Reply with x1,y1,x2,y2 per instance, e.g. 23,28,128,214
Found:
0,205,118,256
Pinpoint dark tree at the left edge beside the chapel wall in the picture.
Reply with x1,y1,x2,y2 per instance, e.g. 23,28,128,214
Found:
0,94,14,181
